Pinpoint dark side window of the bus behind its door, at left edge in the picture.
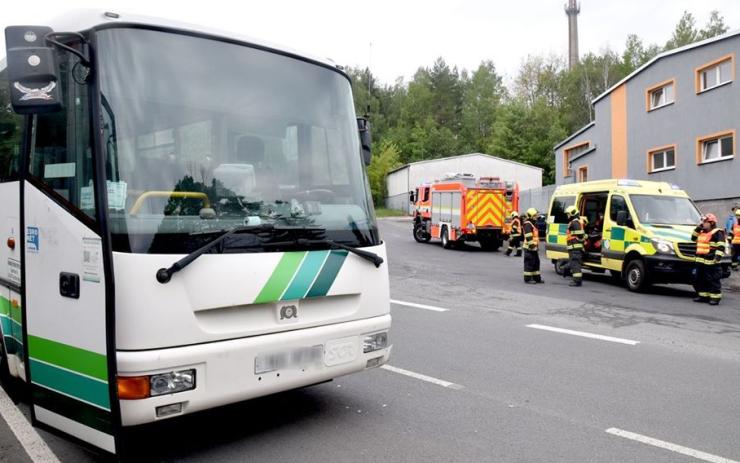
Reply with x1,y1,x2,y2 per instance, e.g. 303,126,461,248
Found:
0,69,23,183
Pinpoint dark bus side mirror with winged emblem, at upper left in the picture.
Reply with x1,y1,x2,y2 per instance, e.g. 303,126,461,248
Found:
5,26,62,114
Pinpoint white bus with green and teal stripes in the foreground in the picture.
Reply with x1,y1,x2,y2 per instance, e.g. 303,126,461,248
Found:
0,12,391,453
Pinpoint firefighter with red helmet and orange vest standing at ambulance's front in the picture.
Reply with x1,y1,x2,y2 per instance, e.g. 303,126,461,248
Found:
691,214,725,305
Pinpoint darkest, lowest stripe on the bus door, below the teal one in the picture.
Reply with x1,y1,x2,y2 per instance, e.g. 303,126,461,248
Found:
31,384,114,435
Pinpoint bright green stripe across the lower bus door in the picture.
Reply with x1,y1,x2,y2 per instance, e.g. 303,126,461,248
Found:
28,334,108,382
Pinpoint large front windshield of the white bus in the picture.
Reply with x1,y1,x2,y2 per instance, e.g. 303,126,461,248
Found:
97,28,378,253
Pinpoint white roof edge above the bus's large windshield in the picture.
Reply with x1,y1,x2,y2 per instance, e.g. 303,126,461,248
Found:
5,9,344,74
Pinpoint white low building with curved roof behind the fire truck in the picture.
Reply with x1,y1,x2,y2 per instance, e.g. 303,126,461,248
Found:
385,153,542,211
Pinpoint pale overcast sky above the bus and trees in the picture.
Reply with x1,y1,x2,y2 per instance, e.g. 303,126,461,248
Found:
0,0,740,83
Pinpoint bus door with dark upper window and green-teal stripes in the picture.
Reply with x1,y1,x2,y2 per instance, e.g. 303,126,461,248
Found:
9,36,120,453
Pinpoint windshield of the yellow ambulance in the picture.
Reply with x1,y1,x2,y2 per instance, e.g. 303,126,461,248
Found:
630,195,701,225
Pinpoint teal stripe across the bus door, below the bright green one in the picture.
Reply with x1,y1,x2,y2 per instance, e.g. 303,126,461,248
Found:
30,358,110,410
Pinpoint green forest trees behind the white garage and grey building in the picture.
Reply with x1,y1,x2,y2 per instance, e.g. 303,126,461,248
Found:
356,11,728,204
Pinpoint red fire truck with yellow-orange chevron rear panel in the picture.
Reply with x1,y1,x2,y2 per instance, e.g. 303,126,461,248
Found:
410,174,519,251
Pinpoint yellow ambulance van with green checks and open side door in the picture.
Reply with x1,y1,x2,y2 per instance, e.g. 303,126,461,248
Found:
545,180,730,291
